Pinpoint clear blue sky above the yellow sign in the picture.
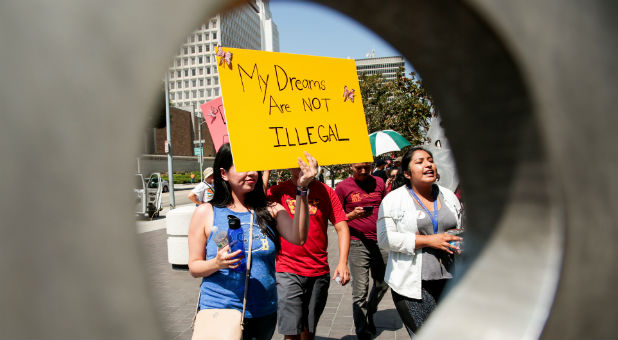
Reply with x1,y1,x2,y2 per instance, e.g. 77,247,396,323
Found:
270,0,412,73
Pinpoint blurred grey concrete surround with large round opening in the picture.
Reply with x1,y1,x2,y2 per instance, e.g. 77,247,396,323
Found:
0,0,618,339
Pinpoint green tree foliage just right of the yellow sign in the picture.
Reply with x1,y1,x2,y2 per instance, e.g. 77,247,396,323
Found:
359,67,435,145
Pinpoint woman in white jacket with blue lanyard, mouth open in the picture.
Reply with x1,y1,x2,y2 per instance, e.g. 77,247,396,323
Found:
377,147,461,337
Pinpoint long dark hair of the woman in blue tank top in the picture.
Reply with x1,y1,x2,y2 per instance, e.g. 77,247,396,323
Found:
210,143,281,250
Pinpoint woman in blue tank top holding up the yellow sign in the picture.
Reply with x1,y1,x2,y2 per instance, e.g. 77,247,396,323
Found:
189,144,318,339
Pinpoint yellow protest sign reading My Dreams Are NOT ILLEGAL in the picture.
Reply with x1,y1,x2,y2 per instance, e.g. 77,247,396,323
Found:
217,47,373,171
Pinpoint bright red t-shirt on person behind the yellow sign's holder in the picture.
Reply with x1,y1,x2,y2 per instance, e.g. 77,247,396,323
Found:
266,181,347,277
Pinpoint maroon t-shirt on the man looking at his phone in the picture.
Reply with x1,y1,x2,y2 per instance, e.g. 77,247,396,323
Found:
335,176,386,241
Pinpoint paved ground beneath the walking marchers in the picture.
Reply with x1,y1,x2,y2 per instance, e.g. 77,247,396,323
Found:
138,205,410,340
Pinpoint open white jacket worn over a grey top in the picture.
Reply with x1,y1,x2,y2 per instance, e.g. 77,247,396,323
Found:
377,185,461,299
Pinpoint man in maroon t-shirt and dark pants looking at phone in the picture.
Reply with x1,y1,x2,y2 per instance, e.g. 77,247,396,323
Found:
335,163,388,340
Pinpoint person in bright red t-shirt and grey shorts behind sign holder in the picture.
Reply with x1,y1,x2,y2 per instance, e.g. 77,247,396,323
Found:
265,168,352,340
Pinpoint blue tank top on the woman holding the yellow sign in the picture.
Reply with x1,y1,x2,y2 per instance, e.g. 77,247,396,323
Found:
199,207,277,318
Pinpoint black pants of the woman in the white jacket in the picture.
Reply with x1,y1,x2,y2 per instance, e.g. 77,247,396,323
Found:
391,280,448,338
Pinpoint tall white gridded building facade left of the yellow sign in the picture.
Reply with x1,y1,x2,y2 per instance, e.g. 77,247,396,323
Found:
168,0,279,112
